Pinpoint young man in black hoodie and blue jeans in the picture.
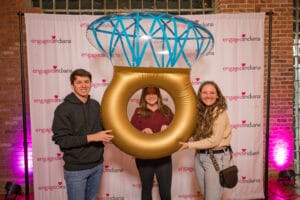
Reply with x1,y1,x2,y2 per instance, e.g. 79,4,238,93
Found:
52,69,113,200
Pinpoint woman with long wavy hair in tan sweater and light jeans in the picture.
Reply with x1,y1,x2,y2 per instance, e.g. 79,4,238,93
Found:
179,81,232,200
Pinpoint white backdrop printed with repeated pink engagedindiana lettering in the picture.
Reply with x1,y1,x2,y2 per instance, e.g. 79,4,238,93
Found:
25,13,265,200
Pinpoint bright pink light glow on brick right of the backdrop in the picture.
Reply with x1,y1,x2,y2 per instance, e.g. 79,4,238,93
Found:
269,129,294,170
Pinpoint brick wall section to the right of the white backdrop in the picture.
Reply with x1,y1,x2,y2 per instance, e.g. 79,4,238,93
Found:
218,0,294,177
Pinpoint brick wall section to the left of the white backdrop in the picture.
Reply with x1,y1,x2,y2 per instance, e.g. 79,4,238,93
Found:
0,0,40,194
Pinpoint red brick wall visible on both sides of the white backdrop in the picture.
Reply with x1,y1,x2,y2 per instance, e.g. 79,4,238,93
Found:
0,0,293,194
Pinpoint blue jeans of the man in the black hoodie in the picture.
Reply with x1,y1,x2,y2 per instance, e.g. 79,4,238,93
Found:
64,164,103,200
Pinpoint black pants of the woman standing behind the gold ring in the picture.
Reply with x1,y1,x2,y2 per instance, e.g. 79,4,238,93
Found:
135,156,172,200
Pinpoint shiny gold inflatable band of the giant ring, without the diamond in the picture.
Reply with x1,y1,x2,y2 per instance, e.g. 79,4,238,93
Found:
101,66,197,159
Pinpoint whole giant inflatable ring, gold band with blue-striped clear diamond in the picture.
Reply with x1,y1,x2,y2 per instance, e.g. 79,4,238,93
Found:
87,12,214,158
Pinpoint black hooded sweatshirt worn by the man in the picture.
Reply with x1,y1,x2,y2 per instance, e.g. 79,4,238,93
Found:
52,93,104,171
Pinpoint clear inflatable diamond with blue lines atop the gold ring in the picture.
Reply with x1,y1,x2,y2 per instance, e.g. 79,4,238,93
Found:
87,12,214,68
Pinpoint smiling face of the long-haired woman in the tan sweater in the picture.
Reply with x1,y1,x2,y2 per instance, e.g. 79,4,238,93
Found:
199,84,218,106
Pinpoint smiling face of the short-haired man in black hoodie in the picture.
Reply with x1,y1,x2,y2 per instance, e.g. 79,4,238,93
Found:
72,76,92,102
